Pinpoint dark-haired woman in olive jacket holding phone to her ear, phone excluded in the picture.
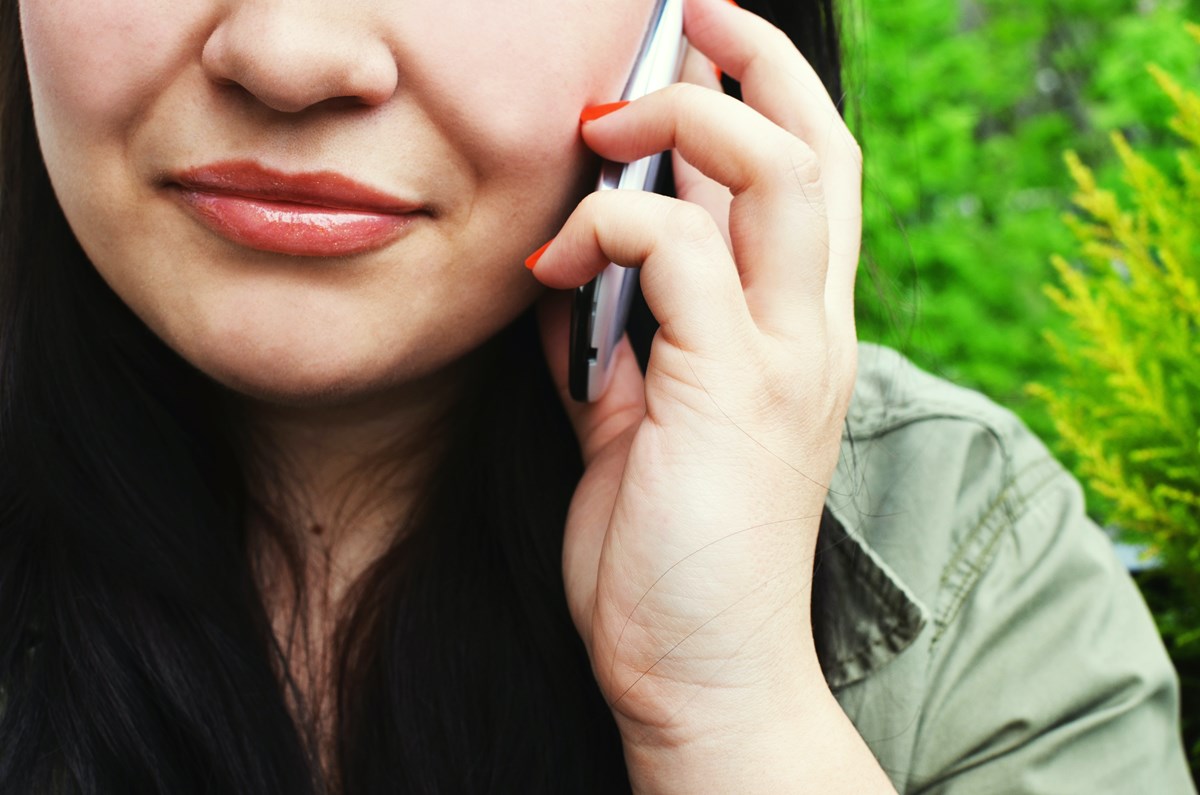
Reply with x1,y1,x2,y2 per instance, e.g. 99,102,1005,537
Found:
0,0,1186,793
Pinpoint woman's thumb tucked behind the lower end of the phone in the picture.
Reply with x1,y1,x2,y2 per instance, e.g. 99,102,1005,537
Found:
535,289,646,467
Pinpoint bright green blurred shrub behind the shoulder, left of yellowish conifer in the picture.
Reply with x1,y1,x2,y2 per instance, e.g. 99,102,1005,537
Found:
844,0,1200,438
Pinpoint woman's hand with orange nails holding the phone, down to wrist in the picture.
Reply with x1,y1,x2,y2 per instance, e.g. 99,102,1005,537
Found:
534,0,862,773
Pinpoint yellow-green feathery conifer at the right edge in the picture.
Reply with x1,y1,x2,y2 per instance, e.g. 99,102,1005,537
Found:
1031,24,1200,647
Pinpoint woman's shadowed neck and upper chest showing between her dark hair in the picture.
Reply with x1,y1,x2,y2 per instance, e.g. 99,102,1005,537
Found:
231,363,469,763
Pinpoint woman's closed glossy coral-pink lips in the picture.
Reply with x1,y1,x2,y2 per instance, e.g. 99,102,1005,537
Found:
167,161,430,257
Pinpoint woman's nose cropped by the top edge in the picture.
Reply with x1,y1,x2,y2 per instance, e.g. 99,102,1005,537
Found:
200,0,398,113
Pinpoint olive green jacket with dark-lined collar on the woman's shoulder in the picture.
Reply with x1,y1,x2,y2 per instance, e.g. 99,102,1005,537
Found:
815,345,1195,795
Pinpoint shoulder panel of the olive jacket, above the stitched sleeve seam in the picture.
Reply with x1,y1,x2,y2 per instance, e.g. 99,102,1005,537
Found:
828,343,1078,641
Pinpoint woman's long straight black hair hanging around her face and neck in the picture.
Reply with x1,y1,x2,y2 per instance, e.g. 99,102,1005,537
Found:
0,0,841,795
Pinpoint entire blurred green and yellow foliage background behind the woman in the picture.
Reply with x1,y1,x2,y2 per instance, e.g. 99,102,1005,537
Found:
841,0,1200,771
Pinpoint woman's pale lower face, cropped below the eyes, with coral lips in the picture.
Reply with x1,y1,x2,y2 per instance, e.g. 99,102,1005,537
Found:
20,0,652,405
